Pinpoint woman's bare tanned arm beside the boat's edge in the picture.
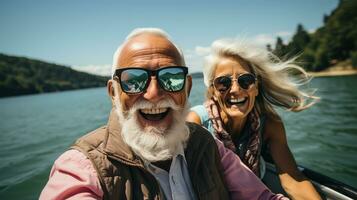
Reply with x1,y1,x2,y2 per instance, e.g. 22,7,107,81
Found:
264,118,321,199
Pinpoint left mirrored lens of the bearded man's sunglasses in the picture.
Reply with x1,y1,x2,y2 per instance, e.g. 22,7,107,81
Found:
120,69,148,93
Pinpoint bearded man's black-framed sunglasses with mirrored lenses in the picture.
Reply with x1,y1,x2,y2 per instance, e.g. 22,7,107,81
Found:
113,66,188,94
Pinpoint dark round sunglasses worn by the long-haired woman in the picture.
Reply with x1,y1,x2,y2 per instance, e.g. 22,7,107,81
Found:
213,73,257,92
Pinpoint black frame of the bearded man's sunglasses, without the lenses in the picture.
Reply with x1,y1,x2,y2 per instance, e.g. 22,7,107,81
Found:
113,66,188,95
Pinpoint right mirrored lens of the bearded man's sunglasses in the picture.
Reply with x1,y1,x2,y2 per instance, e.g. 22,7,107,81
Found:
158,68,186,92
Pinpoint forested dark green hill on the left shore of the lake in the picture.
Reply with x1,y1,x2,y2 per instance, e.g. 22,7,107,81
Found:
0,54,108,97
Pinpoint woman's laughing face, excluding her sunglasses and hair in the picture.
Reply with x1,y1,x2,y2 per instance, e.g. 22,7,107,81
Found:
213,57,258,119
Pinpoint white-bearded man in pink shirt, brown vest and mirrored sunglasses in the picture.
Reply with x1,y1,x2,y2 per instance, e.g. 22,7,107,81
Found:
40,29,284,199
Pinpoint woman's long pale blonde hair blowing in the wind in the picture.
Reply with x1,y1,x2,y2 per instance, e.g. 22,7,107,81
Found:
203,39,319,116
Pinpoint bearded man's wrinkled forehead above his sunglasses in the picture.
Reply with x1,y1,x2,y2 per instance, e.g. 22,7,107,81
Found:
116,34,183,66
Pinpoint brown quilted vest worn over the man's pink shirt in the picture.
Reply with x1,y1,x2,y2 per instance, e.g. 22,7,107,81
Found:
71,110,229,200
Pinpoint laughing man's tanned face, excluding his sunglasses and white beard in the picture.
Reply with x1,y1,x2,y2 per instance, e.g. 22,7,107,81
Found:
108,34,191,134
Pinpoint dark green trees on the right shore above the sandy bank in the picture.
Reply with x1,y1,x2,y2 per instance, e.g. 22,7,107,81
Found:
274,0,357,71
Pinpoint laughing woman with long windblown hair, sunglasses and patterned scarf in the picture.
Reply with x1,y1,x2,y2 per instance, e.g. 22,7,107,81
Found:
187,39,320,199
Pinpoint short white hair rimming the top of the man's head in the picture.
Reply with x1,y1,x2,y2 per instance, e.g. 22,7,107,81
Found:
112,28,185,75
